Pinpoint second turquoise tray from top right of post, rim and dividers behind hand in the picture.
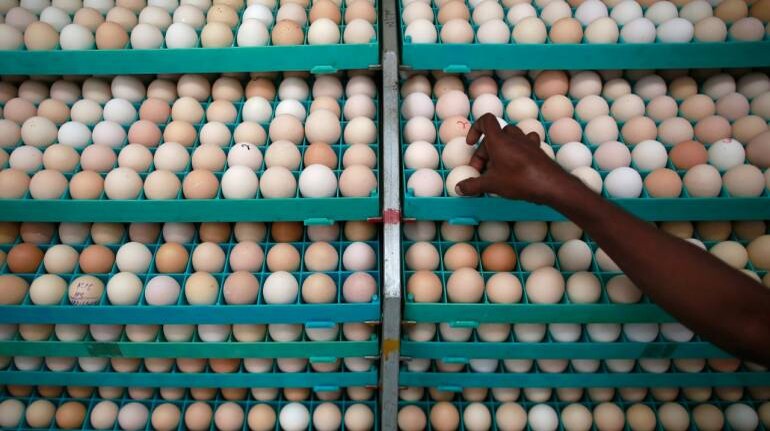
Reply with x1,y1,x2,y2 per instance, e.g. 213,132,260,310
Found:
399,82,770,225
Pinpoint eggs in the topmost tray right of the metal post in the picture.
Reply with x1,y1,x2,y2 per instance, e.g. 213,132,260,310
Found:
401,0,770,44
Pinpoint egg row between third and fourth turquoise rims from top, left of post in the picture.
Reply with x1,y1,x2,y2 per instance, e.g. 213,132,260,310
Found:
0,323,374,343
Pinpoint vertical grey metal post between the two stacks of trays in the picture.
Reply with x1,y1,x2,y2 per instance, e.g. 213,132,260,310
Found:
380,0,401,431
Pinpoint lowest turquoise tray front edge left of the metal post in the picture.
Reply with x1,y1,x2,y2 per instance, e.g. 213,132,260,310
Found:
0,357,377,388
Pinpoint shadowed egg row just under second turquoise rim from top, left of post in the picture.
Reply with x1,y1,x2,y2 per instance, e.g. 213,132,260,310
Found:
0,221,377,246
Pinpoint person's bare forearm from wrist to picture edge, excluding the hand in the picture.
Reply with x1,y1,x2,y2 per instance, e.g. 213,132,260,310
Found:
547,179,770,364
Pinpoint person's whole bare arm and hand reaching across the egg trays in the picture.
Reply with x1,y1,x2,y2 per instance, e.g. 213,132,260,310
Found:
457,114,770,365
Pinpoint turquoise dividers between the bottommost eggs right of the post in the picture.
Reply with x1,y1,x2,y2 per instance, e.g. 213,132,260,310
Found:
398,398,767,431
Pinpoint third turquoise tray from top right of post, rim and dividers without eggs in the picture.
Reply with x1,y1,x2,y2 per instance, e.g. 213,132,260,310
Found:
401,226,767,320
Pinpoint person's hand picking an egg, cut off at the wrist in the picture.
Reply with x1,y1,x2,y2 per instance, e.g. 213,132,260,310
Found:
456,114,576,204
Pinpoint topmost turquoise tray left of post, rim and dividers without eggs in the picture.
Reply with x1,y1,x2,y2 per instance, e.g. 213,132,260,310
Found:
0,1,380,75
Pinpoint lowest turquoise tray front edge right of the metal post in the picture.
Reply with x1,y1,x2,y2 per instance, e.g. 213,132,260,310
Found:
399,360,770,390
